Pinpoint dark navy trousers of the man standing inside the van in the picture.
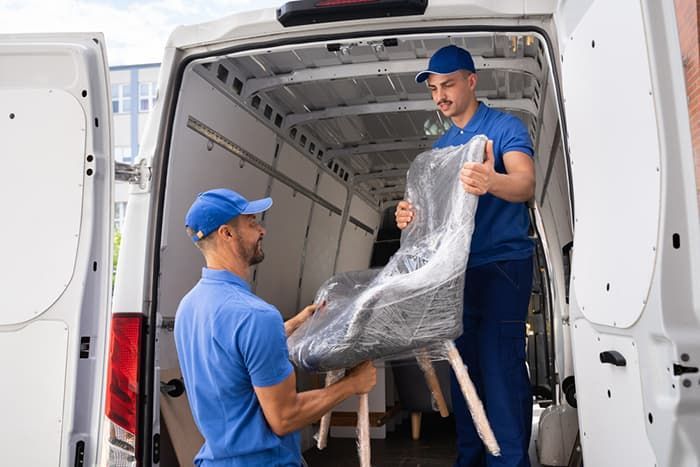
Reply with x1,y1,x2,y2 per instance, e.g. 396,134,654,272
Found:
451,258,532,467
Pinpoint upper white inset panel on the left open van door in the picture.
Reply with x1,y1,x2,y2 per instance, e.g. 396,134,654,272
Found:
0,89,90,325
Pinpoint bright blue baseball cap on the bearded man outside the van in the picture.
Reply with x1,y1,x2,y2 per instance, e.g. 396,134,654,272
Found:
185,188,272,242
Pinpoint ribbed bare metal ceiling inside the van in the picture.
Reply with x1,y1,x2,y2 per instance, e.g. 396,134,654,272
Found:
194,33,549,208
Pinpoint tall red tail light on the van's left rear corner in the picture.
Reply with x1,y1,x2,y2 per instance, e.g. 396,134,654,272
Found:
105,313,143,439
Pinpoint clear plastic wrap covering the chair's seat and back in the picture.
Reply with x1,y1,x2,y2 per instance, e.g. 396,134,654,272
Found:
288,136,486,371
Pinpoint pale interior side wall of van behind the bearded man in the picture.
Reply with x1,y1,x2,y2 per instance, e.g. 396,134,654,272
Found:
158,71,379,368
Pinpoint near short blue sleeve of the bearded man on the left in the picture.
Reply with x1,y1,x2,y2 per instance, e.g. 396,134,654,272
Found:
231,308,294,387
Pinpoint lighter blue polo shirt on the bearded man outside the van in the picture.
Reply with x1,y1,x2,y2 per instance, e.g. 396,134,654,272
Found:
175,268,301,467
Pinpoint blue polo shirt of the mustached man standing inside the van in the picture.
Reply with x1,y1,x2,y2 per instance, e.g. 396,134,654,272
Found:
433,102,534,268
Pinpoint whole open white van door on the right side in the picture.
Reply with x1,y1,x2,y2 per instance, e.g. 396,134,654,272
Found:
555,0,700,467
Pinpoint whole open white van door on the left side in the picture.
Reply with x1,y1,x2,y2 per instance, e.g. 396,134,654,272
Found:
0,34,114,466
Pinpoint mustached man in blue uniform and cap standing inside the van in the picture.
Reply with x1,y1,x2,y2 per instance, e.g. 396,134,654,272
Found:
396,45,535,467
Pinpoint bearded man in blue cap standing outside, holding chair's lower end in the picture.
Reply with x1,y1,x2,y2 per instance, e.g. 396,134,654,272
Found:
175,189,376,467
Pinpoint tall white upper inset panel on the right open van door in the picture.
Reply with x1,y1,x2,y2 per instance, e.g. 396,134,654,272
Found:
562,0,661,328
